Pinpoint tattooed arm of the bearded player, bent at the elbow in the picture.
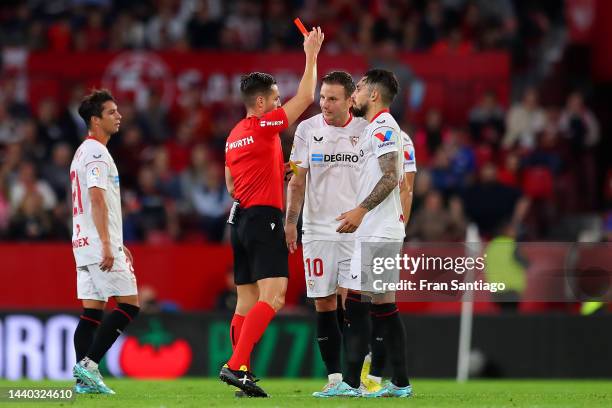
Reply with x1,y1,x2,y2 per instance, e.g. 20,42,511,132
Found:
336,152,399,233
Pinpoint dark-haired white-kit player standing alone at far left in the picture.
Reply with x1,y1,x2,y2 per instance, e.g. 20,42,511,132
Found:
70,90,139,394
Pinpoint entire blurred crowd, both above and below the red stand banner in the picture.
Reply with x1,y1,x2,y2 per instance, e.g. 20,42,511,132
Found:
0,0,612,244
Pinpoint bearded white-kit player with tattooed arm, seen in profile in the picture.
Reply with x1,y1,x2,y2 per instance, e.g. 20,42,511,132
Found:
331,69,412,397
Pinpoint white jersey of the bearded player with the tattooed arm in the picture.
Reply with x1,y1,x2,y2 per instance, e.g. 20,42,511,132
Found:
356,111,406,240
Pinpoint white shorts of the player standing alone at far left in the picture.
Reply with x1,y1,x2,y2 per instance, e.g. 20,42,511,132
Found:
77,256,138,302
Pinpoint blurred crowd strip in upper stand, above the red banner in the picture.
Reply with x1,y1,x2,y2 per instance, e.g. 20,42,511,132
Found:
0,0,563,55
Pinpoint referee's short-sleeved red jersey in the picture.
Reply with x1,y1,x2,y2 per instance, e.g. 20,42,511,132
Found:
225,108,288,210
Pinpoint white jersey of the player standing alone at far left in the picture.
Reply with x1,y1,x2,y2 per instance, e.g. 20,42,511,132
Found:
70,138,123,266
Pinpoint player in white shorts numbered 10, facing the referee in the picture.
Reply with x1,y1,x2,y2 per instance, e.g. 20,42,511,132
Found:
285,71,367,396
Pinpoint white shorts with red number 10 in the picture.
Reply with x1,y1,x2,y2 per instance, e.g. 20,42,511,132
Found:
303,241,354,298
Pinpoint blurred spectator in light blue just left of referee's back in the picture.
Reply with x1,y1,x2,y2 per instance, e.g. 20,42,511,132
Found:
190,165,232,242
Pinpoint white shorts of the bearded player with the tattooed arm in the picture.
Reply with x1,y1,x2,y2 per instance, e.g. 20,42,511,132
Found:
352,237,404,293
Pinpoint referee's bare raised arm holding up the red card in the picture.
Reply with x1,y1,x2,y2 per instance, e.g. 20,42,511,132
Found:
283,27,325,125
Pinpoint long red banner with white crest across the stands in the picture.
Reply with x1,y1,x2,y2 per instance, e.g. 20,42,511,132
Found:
24,51,510,123
